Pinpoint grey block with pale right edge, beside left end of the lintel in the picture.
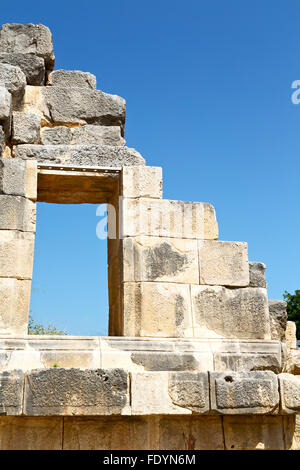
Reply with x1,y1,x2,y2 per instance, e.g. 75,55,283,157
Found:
0,158,37,201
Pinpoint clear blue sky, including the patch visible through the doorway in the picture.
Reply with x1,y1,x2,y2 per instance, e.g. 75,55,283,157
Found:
1,0,300,335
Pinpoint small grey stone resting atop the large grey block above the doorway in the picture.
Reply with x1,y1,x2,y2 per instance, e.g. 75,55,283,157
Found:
47,70,96,90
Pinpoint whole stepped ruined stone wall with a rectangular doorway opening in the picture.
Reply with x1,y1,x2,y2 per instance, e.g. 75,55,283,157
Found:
0,24,300,450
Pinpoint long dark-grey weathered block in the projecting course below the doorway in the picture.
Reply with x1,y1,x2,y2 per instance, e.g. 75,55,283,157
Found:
24,368,128,416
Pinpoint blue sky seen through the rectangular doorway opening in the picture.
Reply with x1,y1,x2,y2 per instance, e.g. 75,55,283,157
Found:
30,203,108,336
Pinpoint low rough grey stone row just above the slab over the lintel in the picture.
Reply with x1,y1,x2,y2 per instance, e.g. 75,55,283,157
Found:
41,124,125,146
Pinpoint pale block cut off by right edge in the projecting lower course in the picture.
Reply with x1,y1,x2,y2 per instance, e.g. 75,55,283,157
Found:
278,374,300,413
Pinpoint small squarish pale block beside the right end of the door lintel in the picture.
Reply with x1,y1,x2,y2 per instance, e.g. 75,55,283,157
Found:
121,166,162,199
